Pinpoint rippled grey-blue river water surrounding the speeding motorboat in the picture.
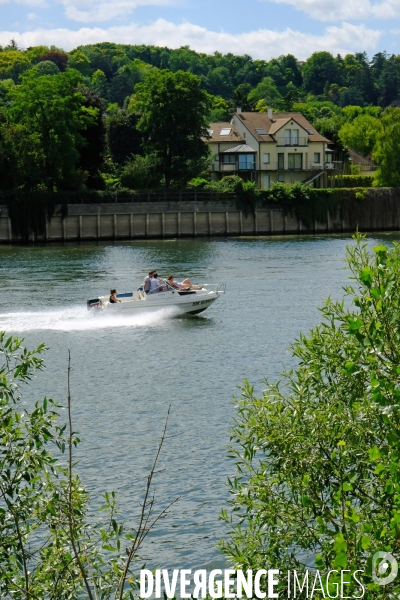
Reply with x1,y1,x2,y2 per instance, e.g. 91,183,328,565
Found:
0,234,395,569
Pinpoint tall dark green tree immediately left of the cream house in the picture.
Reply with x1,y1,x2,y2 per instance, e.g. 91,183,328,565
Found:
135,71,211,188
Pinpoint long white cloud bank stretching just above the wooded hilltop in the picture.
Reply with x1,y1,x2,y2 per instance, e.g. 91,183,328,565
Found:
0,19,382,60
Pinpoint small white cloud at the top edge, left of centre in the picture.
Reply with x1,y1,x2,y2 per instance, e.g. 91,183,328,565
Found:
62,0,174,23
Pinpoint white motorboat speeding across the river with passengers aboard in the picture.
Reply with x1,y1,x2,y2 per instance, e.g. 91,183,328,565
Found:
87,281,225,315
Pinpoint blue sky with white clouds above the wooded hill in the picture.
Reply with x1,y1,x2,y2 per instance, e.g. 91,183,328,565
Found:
0,0,400,60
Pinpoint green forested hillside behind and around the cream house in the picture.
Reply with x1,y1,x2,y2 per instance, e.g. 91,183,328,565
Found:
0,41,400,205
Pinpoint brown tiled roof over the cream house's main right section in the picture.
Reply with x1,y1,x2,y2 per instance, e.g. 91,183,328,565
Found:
236,112,331,143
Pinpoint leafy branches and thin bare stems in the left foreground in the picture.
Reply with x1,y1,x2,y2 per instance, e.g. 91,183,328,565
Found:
0,332,177,600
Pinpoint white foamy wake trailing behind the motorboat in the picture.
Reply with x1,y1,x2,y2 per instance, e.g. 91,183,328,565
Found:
0,306,182,332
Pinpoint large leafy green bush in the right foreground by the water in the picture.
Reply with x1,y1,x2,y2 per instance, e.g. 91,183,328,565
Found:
222,236,400,600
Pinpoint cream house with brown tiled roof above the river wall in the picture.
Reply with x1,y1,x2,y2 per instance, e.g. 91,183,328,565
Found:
206,108,337,189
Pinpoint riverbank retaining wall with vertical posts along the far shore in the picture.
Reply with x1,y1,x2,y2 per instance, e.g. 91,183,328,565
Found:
0,188,400,243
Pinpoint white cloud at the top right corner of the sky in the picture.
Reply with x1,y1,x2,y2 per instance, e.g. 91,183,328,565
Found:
266,0,400,21
